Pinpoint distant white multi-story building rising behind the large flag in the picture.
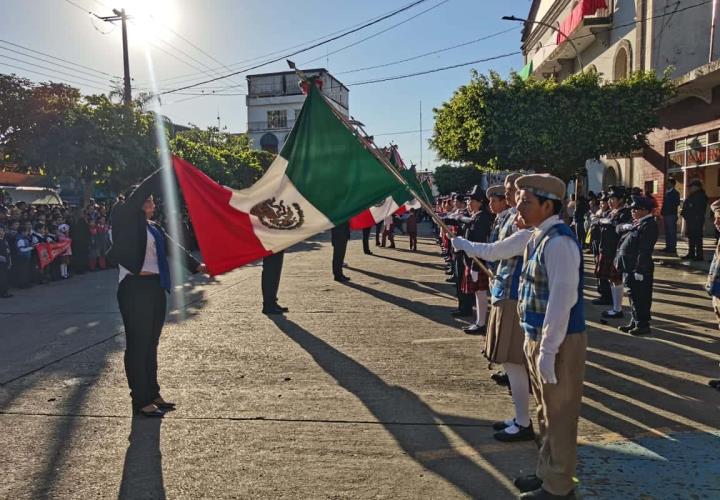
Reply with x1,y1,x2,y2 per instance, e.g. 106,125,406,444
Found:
245,68,349,153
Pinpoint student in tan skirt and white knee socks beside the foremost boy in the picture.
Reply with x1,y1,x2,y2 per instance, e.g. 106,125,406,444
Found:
453,174,535,442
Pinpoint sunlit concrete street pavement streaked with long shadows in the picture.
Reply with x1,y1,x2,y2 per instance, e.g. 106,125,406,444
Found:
0,227,720,499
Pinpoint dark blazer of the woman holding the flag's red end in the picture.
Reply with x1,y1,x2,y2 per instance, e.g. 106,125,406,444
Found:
107,170,200,274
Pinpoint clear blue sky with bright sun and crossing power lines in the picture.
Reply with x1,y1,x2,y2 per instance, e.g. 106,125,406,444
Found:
0,0,531,168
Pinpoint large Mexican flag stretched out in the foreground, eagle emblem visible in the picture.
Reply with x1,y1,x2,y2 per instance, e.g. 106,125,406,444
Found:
173,85,408,275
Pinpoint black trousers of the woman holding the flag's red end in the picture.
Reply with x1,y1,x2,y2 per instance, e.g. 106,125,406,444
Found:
117,275,167,410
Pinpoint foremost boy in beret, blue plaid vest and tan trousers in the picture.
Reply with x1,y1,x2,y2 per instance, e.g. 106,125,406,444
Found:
515,174,587,498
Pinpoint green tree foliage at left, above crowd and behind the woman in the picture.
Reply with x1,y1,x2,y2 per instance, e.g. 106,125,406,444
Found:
0,74,274,200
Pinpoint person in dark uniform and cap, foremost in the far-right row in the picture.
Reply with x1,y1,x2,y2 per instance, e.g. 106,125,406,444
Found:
615,196,658,335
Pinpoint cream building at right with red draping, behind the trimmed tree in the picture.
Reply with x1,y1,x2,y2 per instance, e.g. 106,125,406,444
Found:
522,0,720,208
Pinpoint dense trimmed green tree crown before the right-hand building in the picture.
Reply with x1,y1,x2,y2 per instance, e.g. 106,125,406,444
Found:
430,71,675,179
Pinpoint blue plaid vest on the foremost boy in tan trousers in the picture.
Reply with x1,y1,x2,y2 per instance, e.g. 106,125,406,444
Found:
518,224,585,340
